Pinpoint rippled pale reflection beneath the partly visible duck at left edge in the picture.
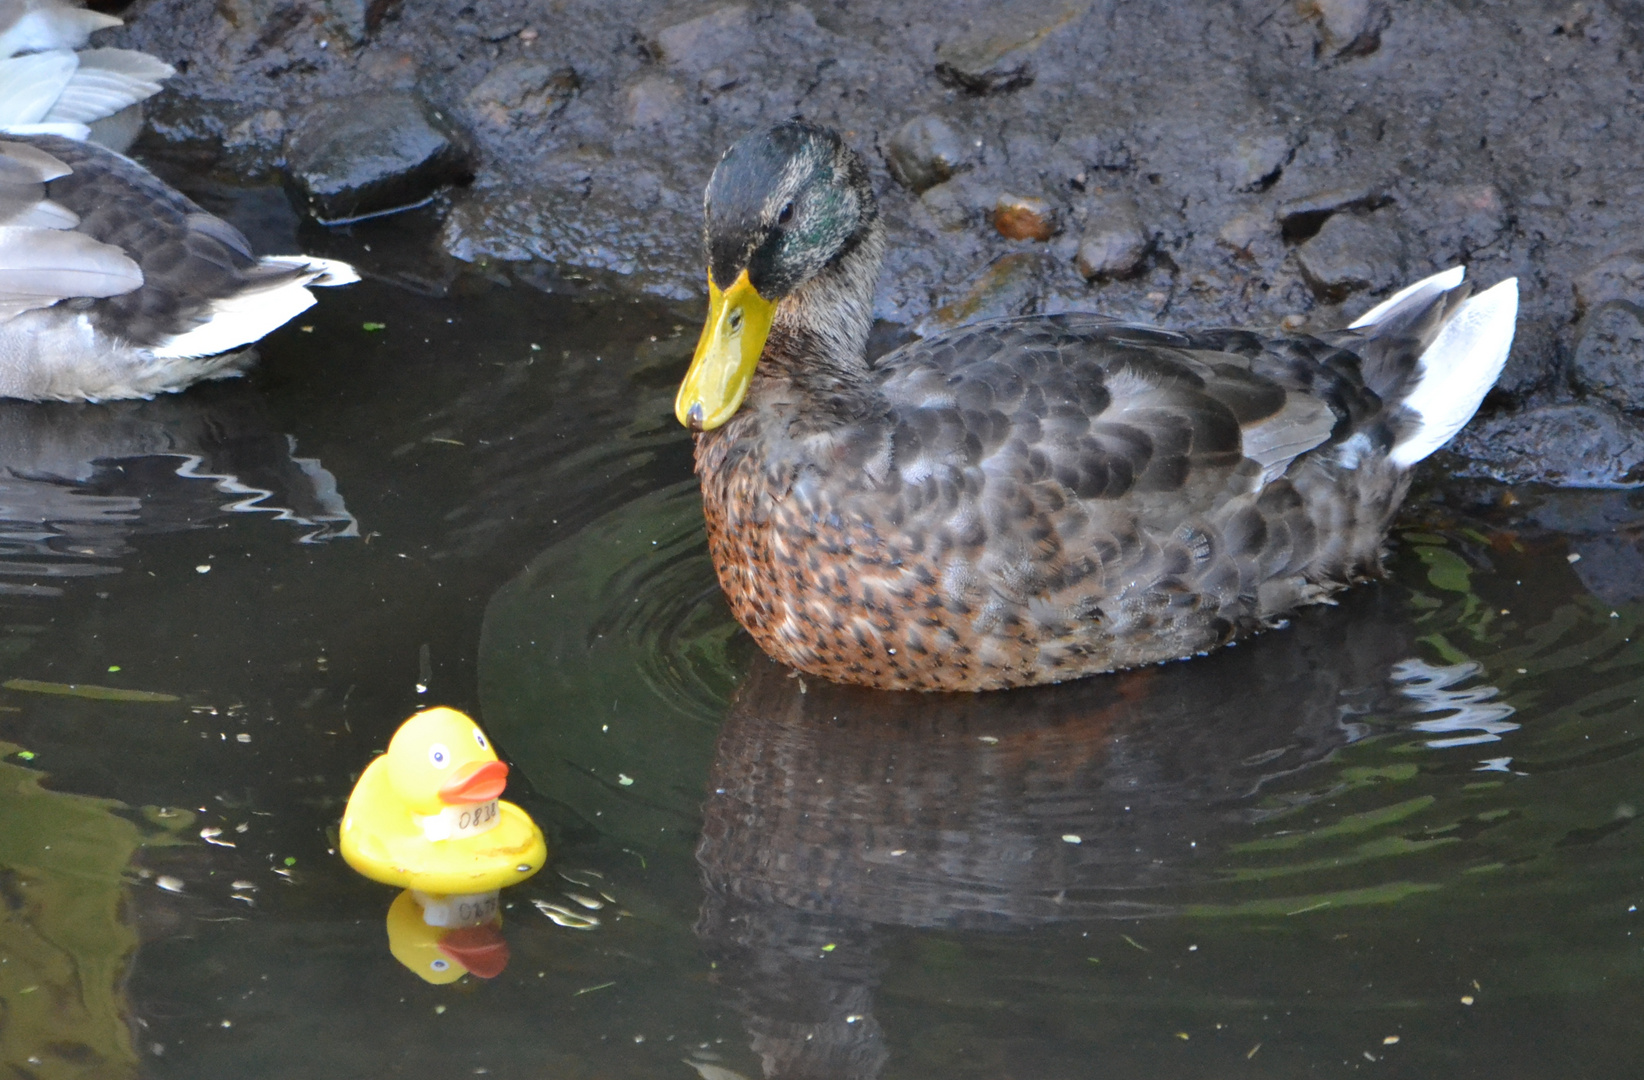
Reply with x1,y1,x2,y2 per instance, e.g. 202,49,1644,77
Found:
0,390,358,595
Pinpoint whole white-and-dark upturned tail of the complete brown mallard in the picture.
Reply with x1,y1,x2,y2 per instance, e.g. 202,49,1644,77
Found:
1348,266,1519,468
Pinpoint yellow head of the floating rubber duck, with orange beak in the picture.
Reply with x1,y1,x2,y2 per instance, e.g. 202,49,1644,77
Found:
386,707,508,814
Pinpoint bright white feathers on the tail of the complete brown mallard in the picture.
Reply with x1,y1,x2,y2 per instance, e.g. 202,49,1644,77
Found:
1387,276,1519,467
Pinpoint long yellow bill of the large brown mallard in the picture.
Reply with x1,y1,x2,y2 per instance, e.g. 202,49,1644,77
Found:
674,270,776,431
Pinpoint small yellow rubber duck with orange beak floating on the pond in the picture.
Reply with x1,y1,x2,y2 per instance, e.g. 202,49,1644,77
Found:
339,708,547,894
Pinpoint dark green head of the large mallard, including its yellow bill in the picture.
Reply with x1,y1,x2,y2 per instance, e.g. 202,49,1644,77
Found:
674,120,878,431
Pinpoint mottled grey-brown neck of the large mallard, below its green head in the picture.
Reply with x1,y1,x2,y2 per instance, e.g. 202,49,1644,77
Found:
750,219,884,418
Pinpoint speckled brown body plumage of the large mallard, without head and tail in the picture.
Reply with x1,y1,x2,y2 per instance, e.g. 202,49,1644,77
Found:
697,316,1414,690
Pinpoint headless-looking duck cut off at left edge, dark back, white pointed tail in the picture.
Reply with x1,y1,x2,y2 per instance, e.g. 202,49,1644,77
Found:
0,133,358,401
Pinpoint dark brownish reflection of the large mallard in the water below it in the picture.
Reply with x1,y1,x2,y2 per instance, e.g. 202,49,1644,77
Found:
697,590,1412,1080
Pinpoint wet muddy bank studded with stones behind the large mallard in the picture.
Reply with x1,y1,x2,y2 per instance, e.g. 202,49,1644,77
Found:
122,0,1644,475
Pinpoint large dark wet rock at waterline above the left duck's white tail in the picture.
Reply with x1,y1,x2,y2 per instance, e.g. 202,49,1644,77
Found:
286,90,470,224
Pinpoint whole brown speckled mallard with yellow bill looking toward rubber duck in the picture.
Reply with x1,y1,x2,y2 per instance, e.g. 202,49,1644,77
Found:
676,120,1517,690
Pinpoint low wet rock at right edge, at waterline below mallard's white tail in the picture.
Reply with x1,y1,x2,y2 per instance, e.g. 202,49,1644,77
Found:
1452,404,1644,488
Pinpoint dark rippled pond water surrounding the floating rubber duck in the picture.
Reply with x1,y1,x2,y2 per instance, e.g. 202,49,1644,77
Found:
0,193,1644,1080
